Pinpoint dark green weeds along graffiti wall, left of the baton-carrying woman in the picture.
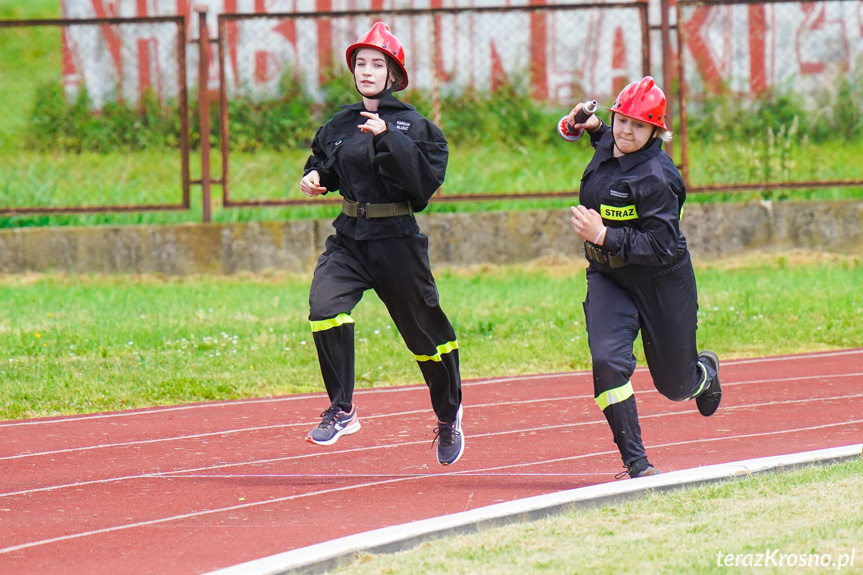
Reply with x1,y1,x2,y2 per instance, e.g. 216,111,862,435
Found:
25,68,559,153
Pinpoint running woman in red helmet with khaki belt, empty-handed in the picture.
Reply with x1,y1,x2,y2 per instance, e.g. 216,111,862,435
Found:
300,22,464,465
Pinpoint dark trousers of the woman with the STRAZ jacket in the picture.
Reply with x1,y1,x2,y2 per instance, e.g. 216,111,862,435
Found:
584,252,715,465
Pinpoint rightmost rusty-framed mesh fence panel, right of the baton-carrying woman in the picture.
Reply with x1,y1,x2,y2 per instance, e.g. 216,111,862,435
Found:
676,0,863,192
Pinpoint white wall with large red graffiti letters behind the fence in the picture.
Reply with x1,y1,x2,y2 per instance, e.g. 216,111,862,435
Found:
61,0,863,107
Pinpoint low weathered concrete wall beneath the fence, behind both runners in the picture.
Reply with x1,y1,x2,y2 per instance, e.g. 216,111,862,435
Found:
0,201,863,275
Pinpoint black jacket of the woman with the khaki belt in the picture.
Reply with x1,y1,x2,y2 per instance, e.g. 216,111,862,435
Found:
304,94,449,240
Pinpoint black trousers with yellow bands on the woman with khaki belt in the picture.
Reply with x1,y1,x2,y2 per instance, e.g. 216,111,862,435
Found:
309,233,461,423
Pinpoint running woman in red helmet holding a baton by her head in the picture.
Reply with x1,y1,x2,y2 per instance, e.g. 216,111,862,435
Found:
566,76,722,477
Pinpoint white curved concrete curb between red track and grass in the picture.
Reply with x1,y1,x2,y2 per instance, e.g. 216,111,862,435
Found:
209,444,863,575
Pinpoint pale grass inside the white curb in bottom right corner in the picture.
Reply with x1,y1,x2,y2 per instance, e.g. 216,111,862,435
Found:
331,458,863,575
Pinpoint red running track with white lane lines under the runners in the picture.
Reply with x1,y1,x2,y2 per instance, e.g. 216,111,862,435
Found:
0,349,863,575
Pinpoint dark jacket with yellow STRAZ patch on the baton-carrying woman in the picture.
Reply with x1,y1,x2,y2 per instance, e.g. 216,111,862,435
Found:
579,126,686,266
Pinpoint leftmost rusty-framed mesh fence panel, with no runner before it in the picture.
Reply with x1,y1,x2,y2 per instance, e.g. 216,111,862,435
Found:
0,17,190,215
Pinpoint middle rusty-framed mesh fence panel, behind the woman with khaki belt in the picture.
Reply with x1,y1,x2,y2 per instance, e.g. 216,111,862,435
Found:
218,2,650,207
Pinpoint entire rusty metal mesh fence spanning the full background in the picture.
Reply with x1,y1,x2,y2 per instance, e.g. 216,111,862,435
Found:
0,0,863,221
